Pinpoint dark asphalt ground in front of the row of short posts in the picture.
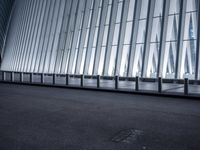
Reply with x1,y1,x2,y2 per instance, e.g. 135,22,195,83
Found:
0,83,200,150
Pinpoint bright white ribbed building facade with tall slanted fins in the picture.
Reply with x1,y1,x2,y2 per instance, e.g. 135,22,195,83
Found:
1,0,200,79
